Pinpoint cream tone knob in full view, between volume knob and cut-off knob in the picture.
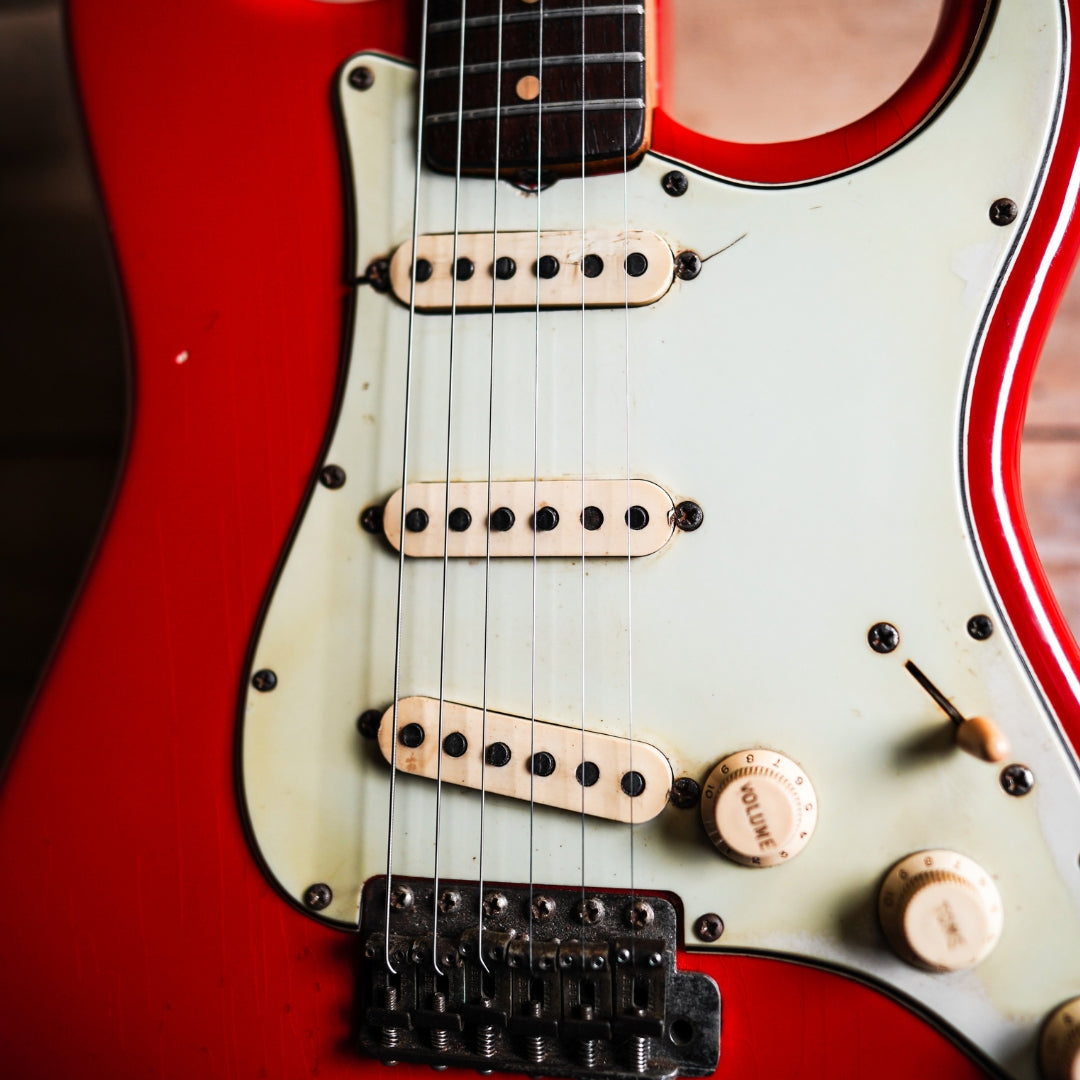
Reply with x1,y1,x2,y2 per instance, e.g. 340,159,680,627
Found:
878,850,1002,971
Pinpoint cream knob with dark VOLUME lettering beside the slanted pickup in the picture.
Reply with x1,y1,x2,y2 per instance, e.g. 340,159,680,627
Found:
701,750,818,866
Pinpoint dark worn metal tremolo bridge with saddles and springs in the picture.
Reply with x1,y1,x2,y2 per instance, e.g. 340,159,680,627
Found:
359,877,720,1080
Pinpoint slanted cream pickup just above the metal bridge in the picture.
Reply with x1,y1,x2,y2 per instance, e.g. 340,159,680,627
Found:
379,697,672,824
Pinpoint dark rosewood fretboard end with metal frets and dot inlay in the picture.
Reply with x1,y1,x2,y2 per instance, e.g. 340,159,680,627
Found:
423,0,651,179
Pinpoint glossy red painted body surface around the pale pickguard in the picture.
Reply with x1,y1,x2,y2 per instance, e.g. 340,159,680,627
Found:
0,0,1080,1080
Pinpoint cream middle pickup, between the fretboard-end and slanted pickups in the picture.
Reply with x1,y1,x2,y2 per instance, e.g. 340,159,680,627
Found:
382,480,674,558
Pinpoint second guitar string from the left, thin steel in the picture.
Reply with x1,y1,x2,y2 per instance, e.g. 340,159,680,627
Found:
431,0,469,975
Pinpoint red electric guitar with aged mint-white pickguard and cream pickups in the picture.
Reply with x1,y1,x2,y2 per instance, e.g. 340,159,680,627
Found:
0,0,1080,1080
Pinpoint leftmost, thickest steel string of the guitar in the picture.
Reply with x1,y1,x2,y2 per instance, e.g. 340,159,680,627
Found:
383,0,428,975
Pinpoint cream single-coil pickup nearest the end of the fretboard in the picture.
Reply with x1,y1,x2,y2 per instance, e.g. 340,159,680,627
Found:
390,229,675,311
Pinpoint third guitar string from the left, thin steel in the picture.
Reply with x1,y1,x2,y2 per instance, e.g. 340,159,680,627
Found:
476,0,503,984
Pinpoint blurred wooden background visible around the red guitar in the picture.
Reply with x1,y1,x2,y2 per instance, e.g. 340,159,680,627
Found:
0,0,1080,755
